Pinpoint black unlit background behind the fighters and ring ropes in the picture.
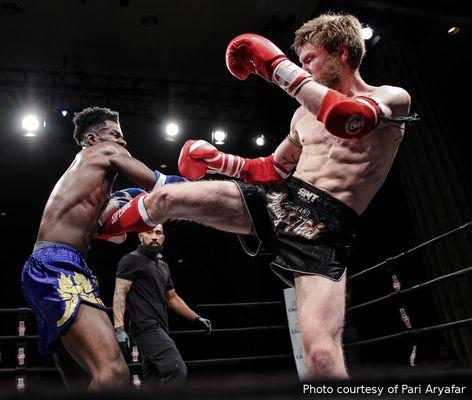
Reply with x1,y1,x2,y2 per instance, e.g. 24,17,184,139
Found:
0,0,472,382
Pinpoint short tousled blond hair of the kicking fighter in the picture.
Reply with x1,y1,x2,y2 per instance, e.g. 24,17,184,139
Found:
293,13,365,70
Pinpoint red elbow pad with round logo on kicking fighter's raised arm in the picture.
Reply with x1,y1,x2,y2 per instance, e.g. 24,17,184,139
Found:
317,89,382,139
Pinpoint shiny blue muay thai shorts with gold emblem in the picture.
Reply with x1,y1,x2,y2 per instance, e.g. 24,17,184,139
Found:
21,241,106,354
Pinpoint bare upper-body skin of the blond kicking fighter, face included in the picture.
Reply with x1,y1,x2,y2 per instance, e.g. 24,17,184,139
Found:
274,44,410,214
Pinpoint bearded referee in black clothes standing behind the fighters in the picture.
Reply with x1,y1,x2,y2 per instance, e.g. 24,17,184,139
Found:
113,225,211,386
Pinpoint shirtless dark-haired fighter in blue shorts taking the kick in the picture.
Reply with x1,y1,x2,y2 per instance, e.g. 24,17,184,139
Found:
22,107,182,389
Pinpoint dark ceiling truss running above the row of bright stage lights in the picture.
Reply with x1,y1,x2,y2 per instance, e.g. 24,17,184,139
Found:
0,68,264,122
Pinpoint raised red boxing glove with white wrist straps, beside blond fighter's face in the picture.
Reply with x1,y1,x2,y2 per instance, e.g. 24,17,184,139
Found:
226,33,313,96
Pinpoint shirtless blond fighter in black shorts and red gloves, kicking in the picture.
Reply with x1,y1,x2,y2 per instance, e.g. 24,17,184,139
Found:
98,14,410,378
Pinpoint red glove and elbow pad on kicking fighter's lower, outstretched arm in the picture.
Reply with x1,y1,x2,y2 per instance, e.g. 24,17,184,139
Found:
179,140,289,183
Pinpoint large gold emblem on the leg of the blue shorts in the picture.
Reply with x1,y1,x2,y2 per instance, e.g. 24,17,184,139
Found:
57,272,104,327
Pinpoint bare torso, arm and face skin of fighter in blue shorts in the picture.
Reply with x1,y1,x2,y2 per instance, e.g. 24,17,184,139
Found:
37,121,156,253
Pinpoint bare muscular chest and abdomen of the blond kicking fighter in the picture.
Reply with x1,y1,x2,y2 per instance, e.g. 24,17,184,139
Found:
294,115,400,214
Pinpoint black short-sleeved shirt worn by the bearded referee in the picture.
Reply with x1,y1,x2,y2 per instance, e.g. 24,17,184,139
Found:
116,245,174,336
